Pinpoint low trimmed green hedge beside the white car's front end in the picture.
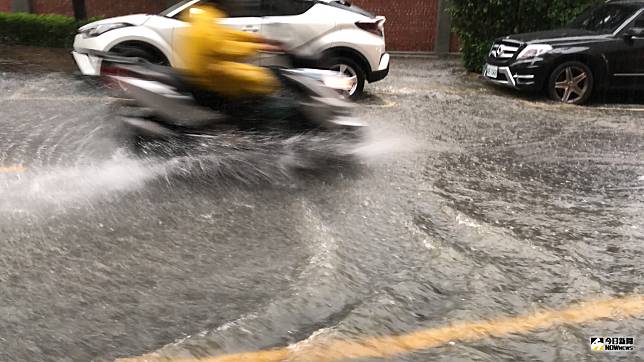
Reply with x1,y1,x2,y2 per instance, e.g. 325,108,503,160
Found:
0,13,97,48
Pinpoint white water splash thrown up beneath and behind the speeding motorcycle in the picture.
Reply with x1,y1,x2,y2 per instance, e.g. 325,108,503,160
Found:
0,132,408,210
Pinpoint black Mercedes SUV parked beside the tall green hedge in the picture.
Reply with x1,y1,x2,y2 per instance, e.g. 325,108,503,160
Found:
483,0,644,104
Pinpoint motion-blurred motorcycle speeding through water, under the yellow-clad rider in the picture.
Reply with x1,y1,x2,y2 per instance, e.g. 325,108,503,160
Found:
93,52,366,140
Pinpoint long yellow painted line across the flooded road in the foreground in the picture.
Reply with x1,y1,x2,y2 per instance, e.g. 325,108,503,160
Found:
118,295,644,362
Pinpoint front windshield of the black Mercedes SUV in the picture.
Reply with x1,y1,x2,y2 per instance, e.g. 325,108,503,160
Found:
569,4,640,34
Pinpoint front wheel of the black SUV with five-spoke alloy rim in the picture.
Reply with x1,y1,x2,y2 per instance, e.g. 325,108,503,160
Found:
548,61,594,104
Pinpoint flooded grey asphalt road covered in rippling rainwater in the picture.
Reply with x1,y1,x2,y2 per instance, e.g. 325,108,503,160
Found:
0,59,644,361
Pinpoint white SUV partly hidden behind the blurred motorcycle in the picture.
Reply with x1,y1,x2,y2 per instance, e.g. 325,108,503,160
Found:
72,0,389,97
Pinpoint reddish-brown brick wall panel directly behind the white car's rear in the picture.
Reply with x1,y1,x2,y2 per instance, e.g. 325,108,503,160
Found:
353,0,438,51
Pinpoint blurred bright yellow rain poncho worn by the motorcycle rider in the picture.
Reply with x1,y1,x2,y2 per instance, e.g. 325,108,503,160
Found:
179,6,278,97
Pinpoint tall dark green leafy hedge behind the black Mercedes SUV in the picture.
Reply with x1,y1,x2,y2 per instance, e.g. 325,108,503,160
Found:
448,0,604,71
